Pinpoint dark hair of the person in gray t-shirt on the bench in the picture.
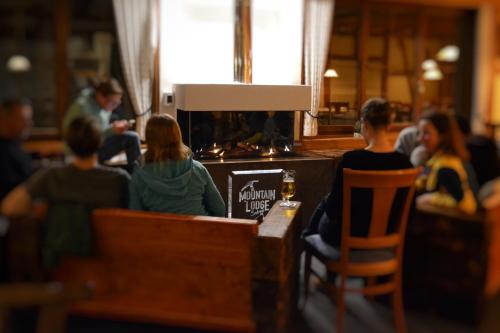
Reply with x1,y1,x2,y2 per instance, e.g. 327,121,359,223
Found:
65,117,102,157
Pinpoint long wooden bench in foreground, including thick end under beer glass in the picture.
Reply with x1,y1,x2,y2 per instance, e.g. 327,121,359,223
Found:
46,202,300,332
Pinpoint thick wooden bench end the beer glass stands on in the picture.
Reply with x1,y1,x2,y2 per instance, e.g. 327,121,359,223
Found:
252,201,302,332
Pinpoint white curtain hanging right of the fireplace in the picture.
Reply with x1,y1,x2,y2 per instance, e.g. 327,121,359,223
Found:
304,0,334,136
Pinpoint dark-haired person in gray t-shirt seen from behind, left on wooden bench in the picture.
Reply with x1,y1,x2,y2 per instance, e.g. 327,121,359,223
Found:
1,117,130,267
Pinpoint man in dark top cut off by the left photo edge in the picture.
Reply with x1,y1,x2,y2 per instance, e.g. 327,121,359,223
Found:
0,99,33,200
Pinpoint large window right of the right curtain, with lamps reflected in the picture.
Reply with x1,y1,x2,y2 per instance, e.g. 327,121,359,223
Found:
320,1,474,125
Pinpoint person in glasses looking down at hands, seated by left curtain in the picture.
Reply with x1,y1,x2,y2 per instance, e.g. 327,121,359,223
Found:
63,78,141,172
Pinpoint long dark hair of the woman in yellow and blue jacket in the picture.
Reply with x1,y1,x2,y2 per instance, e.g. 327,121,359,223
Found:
420,109,469,161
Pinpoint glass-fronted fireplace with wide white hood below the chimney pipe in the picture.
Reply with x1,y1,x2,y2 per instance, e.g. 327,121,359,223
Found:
174,84,311,159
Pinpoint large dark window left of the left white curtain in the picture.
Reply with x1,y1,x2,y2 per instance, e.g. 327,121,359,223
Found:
0,0,132,136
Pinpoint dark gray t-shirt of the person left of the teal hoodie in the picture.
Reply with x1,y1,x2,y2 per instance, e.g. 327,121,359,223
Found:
25,165,130,208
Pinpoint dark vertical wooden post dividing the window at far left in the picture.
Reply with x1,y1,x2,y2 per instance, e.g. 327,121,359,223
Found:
54,0,71,128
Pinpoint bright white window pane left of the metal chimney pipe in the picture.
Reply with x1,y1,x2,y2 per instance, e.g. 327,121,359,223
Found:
160,0,234,91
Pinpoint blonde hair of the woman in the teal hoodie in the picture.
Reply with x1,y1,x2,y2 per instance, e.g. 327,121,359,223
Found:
144,114,191,163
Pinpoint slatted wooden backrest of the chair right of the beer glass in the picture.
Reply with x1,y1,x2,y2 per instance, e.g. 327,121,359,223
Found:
342,168,421,249
